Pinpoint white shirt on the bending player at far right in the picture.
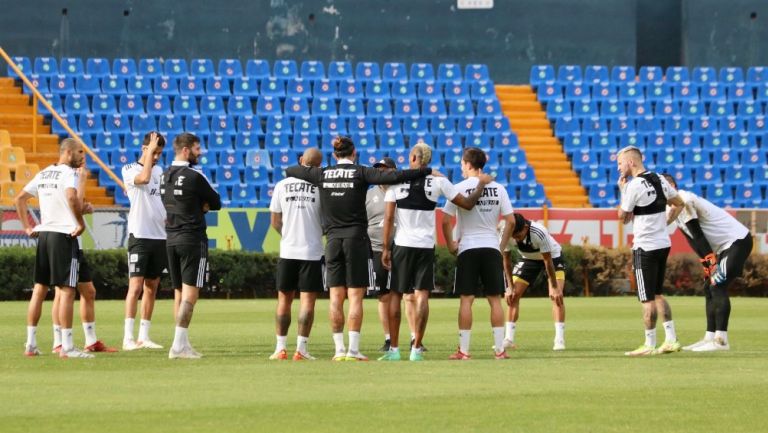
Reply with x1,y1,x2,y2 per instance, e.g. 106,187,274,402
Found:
675,190,749,255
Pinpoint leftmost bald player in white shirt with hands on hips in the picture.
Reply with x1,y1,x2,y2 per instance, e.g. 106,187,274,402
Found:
15,138,95,358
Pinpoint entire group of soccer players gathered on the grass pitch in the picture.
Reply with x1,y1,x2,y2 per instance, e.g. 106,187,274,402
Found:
16,132,752,361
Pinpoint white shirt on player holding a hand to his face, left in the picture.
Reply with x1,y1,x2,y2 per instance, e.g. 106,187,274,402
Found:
123,162,166,239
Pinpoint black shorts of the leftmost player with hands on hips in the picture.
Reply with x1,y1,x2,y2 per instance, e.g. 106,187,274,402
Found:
34,232,82,287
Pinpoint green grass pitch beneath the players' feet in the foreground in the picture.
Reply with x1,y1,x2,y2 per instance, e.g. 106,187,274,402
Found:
0,297,768,433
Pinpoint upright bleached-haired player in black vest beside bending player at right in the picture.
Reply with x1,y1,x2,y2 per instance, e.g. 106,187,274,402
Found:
617,146,684,356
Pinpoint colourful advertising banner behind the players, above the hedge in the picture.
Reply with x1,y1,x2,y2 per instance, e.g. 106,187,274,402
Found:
0,208,768,254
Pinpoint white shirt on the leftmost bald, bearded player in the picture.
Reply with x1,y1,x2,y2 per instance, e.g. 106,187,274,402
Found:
24,164,78,234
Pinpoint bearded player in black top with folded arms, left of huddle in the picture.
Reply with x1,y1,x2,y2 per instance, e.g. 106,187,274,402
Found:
160,132,221,359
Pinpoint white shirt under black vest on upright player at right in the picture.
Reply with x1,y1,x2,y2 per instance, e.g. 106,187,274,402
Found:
621,173,677,251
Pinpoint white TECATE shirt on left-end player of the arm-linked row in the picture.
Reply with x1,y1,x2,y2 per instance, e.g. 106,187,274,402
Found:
269,177,323,260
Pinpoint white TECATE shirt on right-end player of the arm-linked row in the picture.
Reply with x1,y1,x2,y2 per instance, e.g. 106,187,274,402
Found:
443,177,514,254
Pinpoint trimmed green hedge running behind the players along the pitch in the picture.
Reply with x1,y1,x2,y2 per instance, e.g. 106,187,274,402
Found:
0,245,768,300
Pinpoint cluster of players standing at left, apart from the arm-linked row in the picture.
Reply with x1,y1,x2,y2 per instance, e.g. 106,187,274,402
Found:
16,132,221,359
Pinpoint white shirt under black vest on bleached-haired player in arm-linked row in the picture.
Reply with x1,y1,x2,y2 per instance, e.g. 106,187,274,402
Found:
384,175,459,248
